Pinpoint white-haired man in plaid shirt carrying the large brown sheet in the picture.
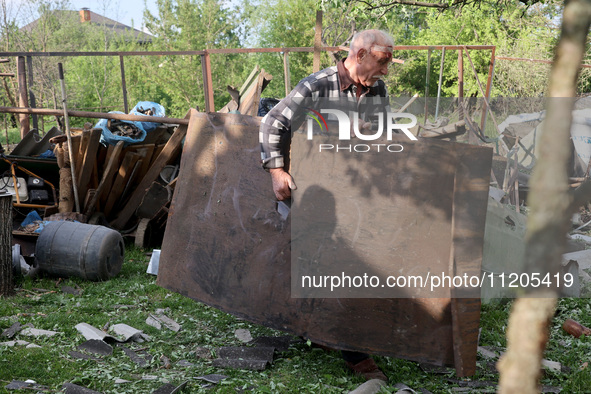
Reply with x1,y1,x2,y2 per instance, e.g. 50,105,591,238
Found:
259,30,394,380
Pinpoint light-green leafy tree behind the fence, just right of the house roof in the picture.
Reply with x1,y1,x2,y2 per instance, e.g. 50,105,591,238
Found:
140,0,244,116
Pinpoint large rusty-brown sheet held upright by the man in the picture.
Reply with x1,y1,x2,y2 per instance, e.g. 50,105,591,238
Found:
158,112,492,375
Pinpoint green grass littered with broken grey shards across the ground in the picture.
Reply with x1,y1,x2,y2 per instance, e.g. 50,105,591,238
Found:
0,246,591,393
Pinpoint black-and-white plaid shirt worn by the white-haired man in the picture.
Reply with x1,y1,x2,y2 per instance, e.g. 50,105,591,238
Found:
259,60,388,169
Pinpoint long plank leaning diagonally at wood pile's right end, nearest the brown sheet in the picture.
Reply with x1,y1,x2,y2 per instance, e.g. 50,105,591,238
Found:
111,109,192,229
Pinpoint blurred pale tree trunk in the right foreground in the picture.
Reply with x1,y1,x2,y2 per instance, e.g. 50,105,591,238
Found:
498,0,591,394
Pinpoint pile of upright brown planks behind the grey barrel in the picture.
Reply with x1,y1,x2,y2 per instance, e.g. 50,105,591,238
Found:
52,117,187,240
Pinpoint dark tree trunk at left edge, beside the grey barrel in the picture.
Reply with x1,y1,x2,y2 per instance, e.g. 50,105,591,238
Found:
0,195,14,297
